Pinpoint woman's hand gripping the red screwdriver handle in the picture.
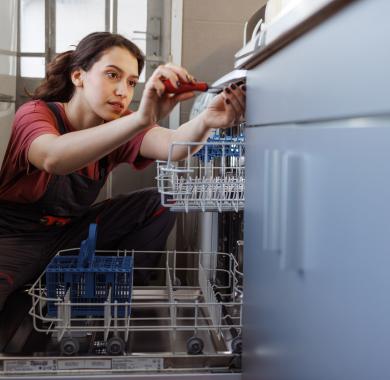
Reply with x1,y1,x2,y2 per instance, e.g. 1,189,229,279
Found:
134,63,195,127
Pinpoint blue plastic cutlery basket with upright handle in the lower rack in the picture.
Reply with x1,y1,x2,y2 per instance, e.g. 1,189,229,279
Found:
46,224,133,317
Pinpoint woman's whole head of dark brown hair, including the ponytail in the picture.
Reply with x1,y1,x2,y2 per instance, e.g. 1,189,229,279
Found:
31,32,145,102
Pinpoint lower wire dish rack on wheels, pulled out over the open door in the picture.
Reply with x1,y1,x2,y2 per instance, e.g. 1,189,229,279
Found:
21,249,243,371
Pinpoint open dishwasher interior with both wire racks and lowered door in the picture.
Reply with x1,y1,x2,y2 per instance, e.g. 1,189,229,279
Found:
0,89,245,378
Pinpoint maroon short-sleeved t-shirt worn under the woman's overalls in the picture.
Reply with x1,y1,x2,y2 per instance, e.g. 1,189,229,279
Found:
0,100,153,203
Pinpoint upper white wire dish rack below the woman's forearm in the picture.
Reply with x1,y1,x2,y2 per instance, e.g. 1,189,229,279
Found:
156,124,245,212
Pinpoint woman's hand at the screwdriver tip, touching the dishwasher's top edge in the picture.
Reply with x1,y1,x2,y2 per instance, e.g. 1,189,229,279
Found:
203,82,246,129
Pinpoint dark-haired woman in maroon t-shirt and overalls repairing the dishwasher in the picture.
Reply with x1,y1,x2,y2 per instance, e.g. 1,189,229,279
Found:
0,32,245,310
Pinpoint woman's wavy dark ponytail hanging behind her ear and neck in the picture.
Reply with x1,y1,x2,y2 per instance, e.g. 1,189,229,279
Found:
32,50,74,102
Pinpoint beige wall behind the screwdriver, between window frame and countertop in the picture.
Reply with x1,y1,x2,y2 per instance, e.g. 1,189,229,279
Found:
181,0,266,122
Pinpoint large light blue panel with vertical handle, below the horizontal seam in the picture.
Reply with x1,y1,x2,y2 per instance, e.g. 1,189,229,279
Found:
243,117,390,380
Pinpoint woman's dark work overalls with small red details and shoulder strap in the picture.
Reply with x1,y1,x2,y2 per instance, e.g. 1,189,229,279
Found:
0,103,175,310
